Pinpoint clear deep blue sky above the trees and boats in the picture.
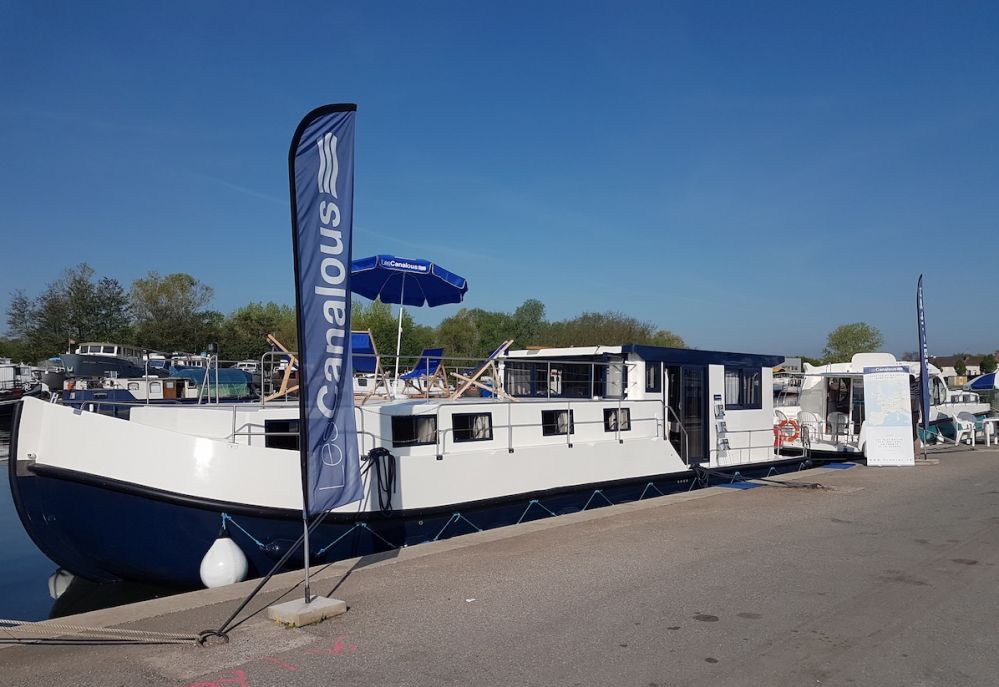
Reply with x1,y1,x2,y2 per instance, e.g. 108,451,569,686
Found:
0,1,999,354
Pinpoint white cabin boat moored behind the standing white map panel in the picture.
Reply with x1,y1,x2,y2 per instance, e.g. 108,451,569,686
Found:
774,353,990,455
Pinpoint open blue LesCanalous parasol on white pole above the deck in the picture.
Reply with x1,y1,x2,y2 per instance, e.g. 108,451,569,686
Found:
350,255,468,378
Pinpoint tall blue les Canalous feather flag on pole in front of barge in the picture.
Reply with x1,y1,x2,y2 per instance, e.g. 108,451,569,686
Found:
288,104,363,603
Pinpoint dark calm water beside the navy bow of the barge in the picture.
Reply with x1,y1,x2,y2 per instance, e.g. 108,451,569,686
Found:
0,428,175,620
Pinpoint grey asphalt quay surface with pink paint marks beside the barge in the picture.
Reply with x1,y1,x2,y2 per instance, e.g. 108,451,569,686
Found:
0,448,999,687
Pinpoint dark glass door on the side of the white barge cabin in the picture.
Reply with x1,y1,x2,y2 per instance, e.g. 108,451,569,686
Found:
666,365,708,465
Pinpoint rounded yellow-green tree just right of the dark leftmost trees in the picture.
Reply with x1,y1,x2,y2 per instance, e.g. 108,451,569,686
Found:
129,272,219,353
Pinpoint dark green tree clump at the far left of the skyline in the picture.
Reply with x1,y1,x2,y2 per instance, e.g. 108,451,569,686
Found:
7,263,131,360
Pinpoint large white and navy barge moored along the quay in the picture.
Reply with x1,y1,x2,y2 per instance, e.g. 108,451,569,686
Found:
3,345,800,586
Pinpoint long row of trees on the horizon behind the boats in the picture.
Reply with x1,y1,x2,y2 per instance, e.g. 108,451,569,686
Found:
0,263,686,362
